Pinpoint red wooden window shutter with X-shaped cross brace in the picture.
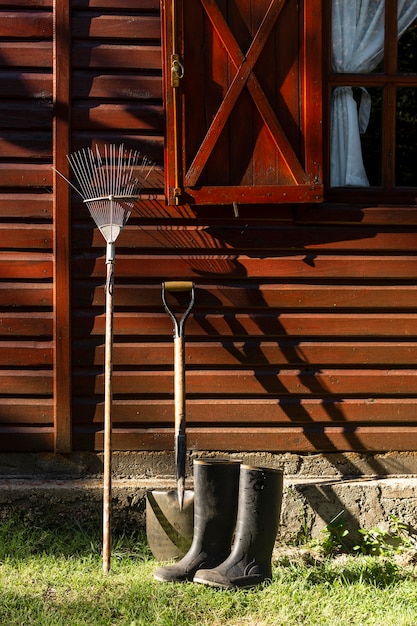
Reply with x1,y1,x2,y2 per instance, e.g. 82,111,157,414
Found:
163,0,322,204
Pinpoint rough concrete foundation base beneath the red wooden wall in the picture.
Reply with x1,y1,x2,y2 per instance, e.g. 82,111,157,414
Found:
0,452,417,542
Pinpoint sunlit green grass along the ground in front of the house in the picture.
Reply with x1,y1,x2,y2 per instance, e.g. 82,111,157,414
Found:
0,519,417,626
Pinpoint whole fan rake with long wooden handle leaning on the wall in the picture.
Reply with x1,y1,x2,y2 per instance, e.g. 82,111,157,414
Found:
62,144,153,574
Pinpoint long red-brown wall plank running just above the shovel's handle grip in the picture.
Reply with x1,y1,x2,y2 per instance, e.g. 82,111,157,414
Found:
73,253,417,281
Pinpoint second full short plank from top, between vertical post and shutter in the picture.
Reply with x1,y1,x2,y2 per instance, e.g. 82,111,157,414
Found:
73,40,162,73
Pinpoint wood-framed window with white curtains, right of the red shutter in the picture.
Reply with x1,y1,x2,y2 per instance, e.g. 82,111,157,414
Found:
326,0,417,202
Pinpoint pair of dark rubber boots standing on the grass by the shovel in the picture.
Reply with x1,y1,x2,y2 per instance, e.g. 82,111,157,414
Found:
154,459,283,588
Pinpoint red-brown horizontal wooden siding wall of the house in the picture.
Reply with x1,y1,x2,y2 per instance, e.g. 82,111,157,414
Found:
0,0,417,452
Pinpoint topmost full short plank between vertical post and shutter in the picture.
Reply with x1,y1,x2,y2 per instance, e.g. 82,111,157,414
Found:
71,11,161,41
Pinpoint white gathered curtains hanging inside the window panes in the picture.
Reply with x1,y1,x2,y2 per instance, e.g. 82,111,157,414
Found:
330,0,417,187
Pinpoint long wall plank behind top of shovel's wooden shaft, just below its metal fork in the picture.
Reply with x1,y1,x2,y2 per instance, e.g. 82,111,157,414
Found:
71,339,417,368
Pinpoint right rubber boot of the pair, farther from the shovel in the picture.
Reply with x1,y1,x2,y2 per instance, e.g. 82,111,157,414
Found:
194,465,283,588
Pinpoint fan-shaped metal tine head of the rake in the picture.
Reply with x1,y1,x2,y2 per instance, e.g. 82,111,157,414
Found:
67,144,153,243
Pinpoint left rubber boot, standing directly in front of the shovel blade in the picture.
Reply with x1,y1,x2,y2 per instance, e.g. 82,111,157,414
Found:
154,459,240,582
